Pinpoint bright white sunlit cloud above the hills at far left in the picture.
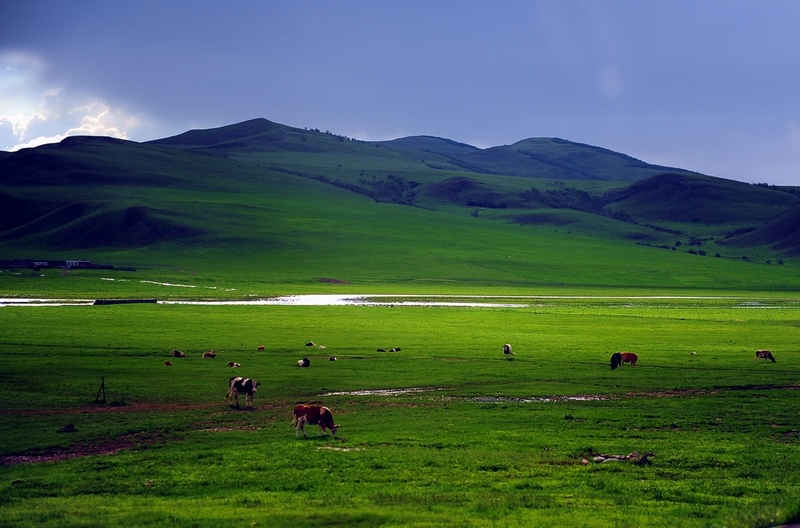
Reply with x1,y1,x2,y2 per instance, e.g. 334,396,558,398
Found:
0,52,139,151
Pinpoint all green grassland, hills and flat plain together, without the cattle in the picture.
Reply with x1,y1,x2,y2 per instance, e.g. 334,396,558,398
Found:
0,121,800,528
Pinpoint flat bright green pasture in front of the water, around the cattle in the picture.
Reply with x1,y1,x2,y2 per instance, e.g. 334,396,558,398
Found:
0,294,800,526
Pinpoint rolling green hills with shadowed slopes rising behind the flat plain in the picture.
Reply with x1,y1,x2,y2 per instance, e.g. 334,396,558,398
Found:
0,119,798,283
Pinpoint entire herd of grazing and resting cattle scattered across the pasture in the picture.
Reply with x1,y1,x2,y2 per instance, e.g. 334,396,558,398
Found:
164,341,775,438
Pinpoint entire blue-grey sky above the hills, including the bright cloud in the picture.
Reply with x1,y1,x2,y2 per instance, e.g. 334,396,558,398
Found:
0,0,800,185
